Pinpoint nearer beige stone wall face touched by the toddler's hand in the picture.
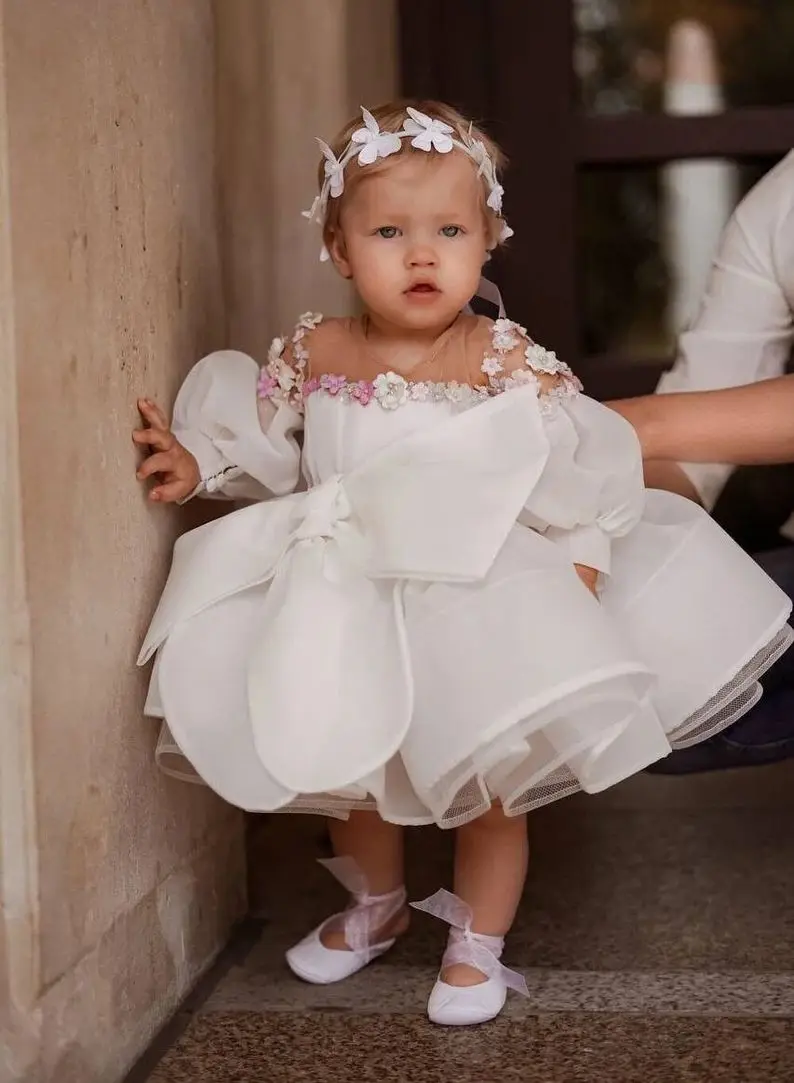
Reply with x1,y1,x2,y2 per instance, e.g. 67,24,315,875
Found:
0,0,244,1083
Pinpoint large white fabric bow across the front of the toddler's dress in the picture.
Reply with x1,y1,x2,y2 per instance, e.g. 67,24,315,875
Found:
139,387,549,806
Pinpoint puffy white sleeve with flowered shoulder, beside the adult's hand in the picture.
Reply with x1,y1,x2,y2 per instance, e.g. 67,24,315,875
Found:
483,321,645,575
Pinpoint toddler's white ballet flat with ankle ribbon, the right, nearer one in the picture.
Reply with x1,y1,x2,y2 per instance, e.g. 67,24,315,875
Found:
411,889,530,1027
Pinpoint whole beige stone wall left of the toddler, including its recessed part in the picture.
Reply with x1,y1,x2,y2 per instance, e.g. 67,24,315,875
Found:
0,0,394,1083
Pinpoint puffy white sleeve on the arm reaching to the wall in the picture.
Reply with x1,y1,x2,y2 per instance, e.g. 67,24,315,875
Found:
172,339,303,500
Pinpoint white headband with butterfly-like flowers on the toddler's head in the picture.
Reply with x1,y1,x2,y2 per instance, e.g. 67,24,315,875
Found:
303,106,512,261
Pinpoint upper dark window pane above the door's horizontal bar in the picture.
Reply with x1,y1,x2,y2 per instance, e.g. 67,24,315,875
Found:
573,0,794,115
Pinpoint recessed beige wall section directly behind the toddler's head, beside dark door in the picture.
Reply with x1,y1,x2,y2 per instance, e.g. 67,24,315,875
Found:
216,0,396,357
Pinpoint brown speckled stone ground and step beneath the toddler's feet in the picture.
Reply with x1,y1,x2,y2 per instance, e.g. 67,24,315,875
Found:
140,764,794,1083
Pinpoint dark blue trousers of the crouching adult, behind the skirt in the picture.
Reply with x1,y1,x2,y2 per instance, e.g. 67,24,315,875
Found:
649,546,794,774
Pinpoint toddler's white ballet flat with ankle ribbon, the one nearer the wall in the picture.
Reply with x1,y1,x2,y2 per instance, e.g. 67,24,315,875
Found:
286,858,405,986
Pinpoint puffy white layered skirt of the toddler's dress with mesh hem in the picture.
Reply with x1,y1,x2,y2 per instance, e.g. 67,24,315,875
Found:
146,492,792,827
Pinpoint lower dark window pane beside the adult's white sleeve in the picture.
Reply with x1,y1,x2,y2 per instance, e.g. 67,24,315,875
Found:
578,158,775,360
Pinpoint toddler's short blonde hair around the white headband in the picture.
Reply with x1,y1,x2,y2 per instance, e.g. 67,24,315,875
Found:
317,99,507,248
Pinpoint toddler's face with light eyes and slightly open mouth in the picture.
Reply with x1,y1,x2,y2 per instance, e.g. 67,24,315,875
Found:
330,151,487,332
